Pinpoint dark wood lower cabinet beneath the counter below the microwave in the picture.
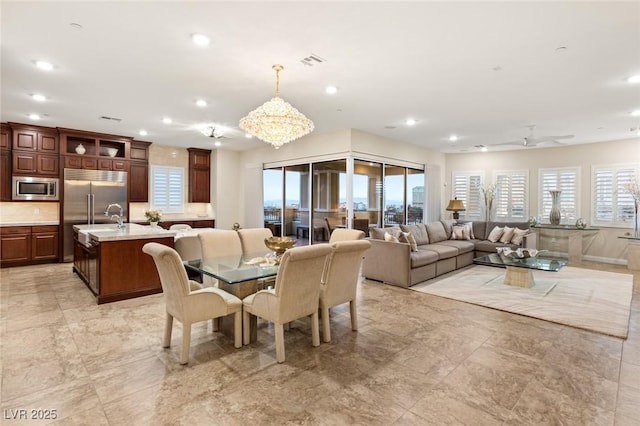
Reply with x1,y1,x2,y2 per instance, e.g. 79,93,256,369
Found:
0,225,59,267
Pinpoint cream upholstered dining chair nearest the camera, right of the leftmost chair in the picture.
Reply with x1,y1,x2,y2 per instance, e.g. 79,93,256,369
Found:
242,244,331,362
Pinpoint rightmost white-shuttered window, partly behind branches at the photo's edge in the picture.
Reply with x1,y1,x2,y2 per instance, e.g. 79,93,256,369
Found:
591,164,639,227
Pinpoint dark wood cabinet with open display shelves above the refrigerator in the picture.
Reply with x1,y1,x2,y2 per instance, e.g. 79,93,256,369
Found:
60,129,131,171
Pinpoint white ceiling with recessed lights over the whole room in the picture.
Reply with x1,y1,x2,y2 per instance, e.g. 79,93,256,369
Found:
0,1,640,152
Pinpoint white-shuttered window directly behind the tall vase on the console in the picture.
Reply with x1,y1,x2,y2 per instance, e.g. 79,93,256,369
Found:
538,167,580,225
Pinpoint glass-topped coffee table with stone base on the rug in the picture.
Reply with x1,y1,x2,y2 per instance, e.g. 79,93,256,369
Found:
473,253,567,288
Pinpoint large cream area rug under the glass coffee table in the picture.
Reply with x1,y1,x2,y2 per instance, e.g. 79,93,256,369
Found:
409,265,633,339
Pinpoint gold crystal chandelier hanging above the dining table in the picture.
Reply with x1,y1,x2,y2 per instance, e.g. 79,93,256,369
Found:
240,65,313,149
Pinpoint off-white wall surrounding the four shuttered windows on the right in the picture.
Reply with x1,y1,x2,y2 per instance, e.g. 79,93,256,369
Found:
443,138,640,263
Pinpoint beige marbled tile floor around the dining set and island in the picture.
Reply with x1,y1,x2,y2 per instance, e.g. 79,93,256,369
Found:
0,264,640,425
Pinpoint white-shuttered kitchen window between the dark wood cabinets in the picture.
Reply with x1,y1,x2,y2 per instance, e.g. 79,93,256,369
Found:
151,166,185,213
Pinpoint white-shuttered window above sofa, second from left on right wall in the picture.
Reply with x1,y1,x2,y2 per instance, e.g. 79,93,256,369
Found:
493,170,529,221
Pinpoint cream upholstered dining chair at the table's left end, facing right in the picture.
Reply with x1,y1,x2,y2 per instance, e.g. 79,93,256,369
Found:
142,243,242,364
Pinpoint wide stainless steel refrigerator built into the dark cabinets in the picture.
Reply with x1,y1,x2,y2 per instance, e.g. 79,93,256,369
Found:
62,169,128,262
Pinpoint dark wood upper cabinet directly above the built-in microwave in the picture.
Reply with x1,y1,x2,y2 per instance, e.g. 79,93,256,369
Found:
9,123,60,177
